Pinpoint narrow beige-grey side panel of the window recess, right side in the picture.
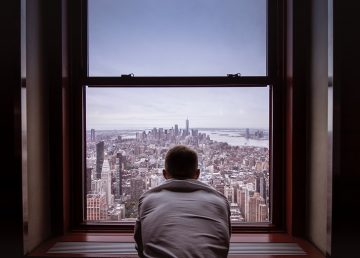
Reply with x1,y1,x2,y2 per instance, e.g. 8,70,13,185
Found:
306,0,329,254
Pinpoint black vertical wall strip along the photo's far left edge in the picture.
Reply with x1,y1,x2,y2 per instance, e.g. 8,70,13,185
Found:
0,0,23,258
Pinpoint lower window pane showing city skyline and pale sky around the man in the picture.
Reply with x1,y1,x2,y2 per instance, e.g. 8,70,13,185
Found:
85,87,271,222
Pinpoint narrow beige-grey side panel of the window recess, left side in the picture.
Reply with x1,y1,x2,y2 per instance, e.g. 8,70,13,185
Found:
25,0,51,252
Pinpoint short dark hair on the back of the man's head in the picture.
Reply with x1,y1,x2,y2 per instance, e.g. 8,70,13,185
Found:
165,145,198,179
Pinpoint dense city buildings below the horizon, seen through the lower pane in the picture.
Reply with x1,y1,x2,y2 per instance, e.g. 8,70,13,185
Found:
86,119,271,222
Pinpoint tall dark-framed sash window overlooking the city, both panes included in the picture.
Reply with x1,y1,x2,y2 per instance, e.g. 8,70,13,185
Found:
76,0,283,230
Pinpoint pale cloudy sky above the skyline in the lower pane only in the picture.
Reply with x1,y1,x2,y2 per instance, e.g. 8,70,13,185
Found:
86,87,269,130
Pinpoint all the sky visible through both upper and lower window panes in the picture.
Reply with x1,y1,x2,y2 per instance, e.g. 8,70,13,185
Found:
86,0,269,130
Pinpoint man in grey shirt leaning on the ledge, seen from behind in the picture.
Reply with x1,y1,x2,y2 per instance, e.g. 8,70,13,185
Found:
134,145,230,258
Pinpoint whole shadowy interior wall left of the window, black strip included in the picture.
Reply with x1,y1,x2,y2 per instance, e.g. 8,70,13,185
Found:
0,0,67,254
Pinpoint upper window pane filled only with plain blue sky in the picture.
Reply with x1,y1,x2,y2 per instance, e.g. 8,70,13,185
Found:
88,0,267,76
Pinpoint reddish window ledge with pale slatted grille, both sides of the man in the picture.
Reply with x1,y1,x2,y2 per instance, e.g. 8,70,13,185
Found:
28,233,325,258
